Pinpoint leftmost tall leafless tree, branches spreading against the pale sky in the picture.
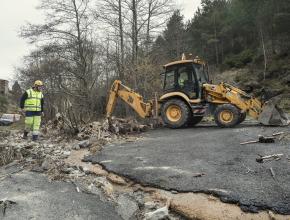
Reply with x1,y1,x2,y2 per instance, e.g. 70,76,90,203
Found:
21,0,100,126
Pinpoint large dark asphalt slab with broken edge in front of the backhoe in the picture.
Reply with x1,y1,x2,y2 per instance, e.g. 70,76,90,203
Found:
84,124,290,214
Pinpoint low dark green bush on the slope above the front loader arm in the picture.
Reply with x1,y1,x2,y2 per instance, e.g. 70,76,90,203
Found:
224,49,254,68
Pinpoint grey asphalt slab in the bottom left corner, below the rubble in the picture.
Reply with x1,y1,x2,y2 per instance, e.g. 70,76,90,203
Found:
0,170,121,220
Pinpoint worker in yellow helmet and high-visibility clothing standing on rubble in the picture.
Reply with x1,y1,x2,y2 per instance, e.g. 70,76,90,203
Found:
20,80,44,141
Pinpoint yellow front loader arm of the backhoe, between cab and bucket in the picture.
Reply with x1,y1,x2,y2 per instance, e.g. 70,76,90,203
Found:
203,83,263,120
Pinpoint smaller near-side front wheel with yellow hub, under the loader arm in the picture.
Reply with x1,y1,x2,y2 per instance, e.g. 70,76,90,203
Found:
214,104,241,128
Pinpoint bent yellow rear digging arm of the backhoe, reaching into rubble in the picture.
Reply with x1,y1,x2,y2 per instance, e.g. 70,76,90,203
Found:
106,80,153,118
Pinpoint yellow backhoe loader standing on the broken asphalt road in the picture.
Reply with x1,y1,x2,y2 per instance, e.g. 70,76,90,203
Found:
106,56,289,128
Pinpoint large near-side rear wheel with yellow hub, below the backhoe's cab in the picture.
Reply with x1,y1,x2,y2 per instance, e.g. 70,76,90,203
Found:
161,99,191,128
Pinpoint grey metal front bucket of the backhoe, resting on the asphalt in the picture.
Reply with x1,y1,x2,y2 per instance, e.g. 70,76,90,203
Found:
258,96,289,126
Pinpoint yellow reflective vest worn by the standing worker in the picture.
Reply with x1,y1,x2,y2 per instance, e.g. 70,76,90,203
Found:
24,89,43,112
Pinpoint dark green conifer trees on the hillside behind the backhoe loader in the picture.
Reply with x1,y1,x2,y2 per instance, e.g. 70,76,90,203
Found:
153,0,290,67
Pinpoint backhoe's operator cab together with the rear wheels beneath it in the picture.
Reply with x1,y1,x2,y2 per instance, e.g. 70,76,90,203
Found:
159,58,209,128
